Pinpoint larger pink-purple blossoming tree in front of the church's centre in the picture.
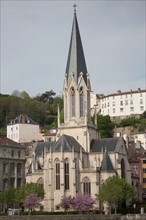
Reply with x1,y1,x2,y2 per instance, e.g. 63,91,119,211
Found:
72,194,95,212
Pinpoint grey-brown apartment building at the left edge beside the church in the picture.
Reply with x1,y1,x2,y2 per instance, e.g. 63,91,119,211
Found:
0,136,25,191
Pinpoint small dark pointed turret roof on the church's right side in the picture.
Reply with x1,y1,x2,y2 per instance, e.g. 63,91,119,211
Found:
101,150,114,171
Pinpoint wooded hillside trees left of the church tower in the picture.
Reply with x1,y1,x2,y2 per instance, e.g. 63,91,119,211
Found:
0,90,63,134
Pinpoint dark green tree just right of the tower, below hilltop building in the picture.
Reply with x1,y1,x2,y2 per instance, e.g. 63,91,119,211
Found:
97,115,114,138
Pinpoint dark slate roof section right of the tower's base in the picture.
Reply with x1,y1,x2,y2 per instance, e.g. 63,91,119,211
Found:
90,137,122,152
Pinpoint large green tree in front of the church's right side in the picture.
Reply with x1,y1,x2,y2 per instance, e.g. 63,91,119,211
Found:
97,176,135,213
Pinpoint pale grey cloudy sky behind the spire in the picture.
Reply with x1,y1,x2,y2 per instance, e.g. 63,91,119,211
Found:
0,0,146,97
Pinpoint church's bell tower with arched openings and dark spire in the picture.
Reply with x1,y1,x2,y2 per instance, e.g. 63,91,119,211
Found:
57,5,97,152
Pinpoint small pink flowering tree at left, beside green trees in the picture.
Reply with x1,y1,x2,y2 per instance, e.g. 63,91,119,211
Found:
24,193,41,214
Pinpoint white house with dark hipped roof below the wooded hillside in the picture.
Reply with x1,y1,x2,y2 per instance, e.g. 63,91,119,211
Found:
7,115,39,143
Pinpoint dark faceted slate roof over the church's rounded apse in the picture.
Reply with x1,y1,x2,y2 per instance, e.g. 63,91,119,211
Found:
52,135,84,152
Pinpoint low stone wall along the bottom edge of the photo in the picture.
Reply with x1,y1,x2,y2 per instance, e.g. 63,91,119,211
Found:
0,214,146,220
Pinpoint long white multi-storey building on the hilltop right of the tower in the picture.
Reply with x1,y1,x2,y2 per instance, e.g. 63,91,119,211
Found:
100,89,146,119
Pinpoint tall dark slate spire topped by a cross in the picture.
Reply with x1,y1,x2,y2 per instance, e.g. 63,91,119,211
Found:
66,5,87,82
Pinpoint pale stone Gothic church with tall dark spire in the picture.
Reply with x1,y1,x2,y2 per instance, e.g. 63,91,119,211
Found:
26,8,131,211
